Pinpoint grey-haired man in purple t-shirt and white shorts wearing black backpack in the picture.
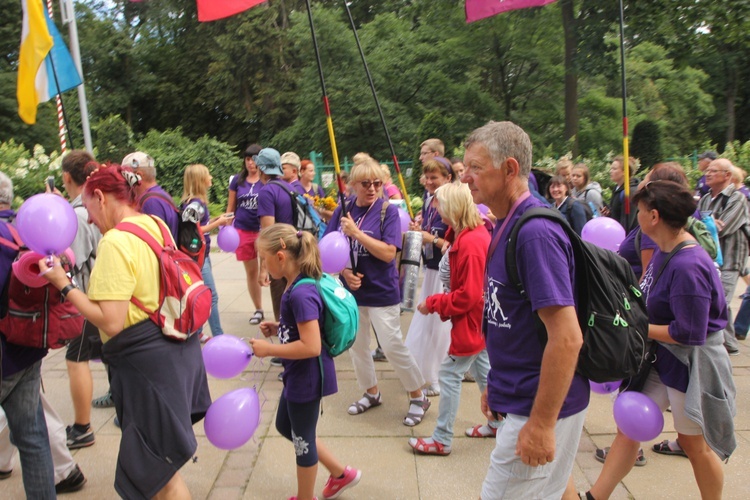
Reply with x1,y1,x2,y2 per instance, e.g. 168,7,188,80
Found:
462,122,589,500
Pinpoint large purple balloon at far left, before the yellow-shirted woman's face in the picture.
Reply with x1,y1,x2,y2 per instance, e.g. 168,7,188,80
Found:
16,193,78,255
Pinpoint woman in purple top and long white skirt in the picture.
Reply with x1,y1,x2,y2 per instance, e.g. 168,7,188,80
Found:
404,156,453,396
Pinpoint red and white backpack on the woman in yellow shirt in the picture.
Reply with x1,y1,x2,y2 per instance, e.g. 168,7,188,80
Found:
115,216,211,341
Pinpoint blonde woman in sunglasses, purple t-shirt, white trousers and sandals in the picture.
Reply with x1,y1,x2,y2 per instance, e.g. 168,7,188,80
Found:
326,158,430,426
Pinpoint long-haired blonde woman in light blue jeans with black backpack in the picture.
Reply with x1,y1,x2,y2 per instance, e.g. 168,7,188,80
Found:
180,163,234,339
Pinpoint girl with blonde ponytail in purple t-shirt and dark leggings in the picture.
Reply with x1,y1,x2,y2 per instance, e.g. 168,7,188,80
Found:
250,224,362,500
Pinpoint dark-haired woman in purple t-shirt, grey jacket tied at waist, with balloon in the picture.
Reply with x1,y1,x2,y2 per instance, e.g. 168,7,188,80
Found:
586,180,736,499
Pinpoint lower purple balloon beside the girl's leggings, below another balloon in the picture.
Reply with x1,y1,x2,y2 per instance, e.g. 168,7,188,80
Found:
203,387,260,450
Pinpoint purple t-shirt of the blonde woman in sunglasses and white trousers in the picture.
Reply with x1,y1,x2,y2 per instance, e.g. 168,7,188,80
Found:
326,199,402,307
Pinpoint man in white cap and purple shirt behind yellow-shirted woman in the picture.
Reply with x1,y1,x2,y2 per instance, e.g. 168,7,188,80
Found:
122,151,179,242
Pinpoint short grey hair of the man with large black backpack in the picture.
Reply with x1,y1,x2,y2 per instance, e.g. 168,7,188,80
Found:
464,121,532,179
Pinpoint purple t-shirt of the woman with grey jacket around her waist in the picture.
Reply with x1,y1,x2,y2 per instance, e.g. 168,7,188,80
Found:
641,245,727,392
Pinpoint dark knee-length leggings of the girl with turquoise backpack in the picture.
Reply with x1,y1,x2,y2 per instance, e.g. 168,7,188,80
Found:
276,394,320,467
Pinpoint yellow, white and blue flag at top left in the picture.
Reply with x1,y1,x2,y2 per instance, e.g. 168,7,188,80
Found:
16,0,82,125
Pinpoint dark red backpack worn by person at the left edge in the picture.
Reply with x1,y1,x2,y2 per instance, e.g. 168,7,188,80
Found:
0,223,84,349
